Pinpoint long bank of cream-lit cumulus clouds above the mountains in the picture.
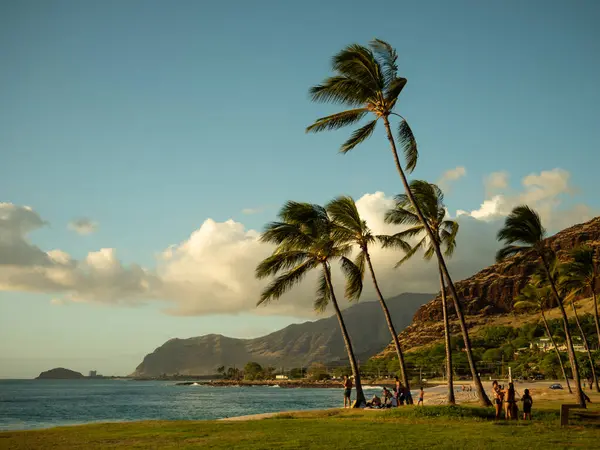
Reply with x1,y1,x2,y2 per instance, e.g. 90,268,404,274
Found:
0,169,597,317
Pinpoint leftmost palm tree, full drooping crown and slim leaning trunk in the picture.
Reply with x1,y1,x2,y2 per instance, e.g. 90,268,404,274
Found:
256,201,365,407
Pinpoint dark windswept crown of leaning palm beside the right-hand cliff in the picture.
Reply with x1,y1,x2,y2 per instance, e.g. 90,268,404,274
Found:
498,205,546,247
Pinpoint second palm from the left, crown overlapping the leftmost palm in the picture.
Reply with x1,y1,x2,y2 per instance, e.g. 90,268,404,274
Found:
325,196,410,400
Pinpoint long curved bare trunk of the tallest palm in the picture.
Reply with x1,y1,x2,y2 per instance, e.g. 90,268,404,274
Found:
383,116,492,406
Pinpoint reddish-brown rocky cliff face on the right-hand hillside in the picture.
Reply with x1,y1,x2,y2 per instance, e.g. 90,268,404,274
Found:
413,217,600,325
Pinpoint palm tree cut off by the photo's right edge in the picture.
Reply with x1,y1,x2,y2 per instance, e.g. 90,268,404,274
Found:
562,245,600,348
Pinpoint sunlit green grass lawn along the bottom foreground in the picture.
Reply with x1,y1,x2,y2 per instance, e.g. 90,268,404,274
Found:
0,407,600,450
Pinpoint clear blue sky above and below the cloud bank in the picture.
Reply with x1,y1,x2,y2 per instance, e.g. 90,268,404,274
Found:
0,1,600,376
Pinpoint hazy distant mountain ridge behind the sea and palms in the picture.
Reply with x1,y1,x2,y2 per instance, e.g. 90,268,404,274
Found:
131,293,434,377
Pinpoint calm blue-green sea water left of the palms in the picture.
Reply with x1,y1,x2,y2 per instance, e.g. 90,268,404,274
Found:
0,380,394,430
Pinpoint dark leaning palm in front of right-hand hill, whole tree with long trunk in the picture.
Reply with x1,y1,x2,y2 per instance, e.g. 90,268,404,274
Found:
496,205,586,408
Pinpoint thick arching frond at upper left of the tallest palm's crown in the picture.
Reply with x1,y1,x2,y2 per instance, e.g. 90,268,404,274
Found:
331,44,385,91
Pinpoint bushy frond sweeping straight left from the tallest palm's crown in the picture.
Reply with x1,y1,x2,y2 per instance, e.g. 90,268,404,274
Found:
309,76,376,106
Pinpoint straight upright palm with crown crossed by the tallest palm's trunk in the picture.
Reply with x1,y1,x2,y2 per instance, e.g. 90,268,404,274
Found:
384,180,460,405
